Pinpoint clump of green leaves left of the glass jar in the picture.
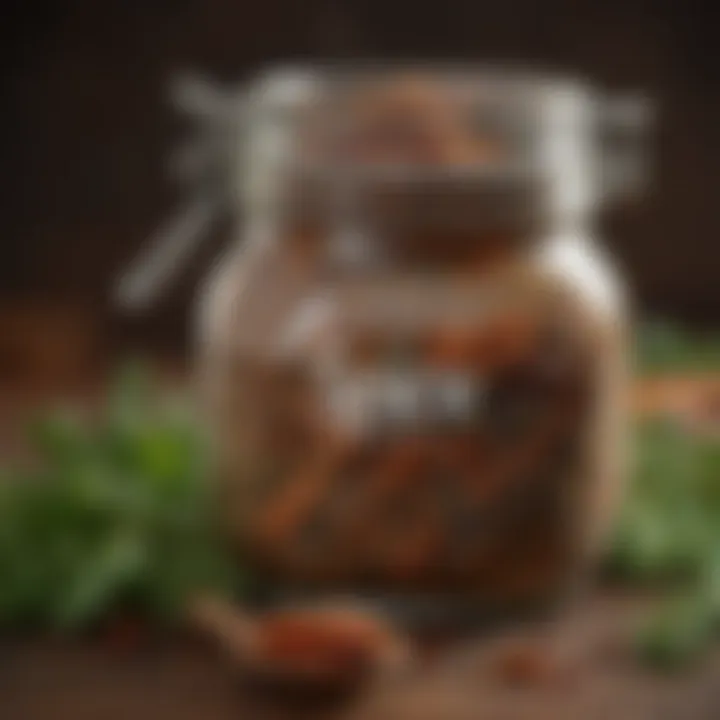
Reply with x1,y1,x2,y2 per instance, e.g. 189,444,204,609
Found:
0,365,240,629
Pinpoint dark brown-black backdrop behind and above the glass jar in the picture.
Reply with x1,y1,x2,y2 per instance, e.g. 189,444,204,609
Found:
0,0,720,360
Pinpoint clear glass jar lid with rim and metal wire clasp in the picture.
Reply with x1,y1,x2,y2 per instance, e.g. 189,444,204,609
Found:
117,65,648,309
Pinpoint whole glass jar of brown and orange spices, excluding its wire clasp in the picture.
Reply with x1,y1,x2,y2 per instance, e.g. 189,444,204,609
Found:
118,68,648,607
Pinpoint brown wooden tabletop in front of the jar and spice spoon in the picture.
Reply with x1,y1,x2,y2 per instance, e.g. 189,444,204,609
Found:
0,594,720,720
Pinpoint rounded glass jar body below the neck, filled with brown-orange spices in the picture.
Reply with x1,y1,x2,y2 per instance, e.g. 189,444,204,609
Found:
201,221,626,607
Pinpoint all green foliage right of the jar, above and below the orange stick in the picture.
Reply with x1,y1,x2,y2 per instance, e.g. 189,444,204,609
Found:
608,322,720,669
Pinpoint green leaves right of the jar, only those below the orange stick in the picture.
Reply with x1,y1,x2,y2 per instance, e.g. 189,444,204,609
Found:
610,420,720,669
